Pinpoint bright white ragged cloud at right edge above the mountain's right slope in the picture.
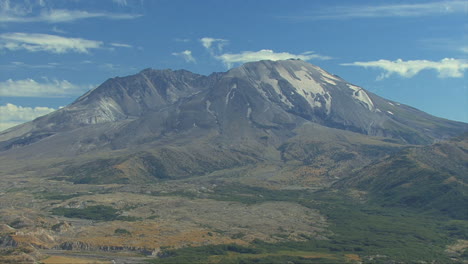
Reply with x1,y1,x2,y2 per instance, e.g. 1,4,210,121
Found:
341,58,468,79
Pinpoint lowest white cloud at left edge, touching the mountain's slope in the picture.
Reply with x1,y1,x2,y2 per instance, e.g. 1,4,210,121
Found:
0,104,56,131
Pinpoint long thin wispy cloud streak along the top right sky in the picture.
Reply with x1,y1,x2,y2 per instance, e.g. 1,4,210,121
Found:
283,0,468,21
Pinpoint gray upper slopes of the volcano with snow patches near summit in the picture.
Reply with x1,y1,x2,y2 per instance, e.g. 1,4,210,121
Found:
0,60,468,157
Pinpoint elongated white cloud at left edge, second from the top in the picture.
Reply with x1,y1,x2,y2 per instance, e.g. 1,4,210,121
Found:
0,33,103,53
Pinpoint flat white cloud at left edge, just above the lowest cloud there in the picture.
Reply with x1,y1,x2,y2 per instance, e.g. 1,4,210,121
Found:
0,79,93,98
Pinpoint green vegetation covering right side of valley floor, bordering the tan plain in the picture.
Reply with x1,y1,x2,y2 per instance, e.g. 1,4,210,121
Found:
160,185,468,263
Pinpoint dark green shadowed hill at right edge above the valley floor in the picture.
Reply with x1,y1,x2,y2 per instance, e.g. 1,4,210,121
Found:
348,154,468,220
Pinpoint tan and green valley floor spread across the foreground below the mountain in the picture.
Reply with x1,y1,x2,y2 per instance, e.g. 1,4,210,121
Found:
0,168,468,264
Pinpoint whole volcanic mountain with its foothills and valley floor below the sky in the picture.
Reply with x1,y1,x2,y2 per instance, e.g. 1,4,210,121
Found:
0,60,468,263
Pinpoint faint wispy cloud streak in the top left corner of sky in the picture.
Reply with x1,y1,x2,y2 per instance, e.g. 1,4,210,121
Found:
0,0,141,23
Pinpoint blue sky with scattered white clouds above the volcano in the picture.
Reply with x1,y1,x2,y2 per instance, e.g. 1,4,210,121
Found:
0,0,468,130
